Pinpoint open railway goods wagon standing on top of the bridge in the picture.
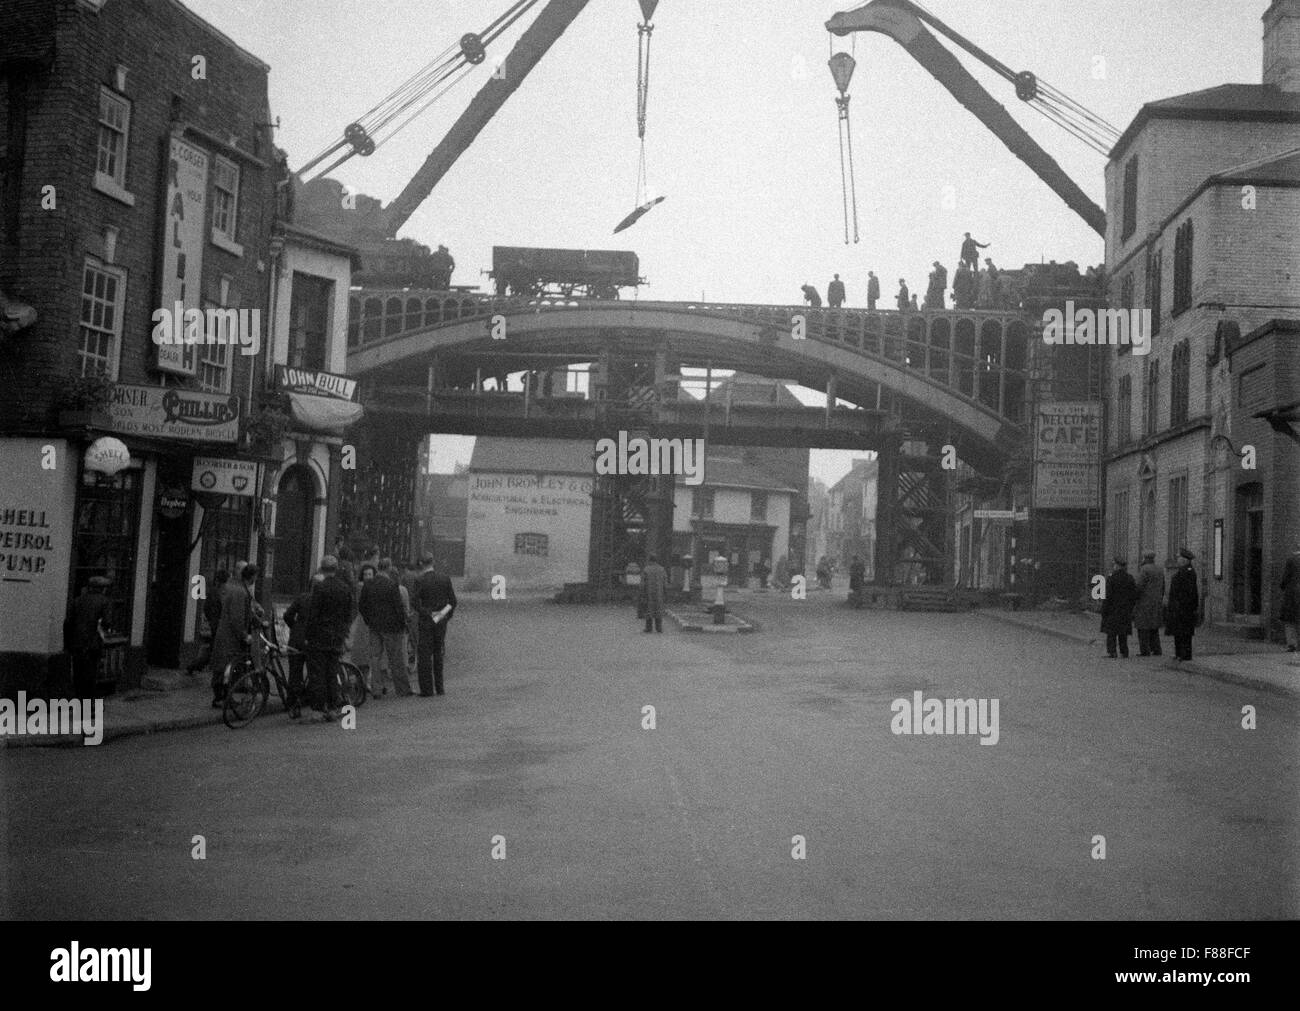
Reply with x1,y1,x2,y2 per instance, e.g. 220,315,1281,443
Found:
491,246,645,299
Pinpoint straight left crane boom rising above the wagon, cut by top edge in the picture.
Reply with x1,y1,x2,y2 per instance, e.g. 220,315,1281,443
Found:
384,0,589,235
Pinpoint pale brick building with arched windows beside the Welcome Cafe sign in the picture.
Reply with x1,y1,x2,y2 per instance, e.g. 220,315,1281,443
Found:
1105,0,1300,629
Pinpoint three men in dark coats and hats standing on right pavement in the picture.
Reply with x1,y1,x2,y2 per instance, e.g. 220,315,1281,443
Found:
1101,547,1201,660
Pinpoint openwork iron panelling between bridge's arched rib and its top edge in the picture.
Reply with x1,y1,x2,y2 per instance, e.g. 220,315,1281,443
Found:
348,288,1036,422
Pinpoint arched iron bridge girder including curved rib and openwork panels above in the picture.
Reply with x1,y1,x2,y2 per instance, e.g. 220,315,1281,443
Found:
348,291,1036,456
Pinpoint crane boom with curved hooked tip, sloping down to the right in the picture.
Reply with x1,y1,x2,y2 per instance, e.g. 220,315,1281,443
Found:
826,0,1106,237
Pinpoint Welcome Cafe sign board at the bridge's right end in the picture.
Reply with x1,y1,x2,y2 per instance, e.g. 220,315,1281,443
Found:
1034,400,1101,509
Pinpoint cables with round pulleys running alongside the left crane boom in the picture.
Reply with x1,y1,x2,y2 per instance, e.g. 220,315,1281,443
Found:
296,0,541,179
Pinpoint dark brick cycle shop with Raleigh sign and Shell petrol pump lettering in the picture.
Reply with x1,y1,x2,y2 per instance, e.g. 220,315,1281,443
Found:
0,0,277,691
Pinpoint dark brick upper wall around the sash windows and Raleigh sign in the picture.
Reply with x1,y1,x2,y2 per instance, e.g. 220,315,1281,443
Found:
0,0,274,431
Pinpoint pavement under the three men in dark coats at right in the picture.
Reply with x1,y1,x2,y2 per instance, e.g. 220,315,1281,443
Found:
978,609,1300,698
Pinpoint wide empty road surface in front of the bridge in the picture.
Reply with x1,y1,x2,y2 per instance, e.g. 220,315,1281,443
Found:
0,594,1300,920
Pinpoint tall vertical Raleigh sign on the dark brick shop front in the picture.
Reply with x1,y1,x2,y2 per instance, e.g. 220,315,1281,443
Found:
156,136,208,376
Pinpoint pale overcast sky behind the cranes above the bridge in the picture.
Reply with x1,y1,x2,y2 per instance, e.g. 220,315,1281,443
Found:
185,0,1269,482
